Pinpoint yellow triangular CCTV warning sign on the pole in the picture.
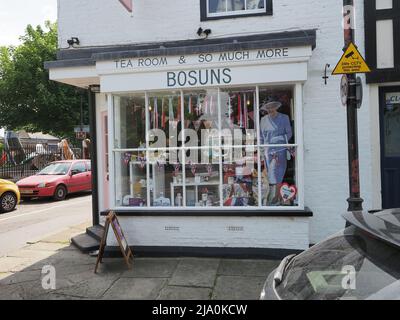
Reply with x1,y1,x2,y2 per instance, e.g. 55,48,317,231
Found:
332,43,371,75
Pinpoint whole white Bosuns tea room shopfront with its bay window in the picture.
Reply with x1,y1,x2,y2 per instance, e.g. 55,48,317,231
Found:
46,31,315,255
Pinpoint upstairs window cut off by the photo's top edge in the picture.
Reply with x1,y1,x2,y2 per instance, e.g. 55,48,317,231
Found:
200,0,272,20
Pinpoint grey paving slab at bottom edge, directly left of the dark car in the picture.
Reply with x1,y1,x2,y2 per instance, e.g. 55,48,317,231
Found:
212,276,266,300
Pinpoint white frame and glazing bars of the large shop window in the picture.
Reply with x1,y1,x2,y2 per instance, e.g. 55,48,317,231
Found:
108,83,306,215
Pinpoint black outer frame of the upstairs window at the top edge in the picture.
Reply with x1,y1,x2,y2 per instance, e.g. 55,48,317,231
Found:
200,0,273,21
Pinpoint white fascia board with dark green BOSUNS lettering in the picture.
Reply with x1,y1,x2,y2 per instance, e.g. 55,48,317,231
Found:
100,61,308,92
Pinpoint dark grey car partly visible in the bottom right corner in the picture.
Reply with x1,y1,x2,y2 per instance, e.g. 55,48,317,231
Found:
261,209,400,300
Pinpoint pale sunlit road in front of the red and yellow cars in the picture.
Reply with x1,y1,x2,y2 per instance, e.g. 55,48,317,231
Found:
0,193,92,257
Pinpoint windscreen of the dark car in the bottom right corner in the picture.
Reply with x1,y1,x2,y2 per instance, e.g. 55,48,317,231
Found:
276,227,400,300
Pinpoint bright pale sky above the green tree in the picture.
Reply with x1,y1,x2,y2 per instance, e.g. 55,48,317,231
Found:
0,0,57,46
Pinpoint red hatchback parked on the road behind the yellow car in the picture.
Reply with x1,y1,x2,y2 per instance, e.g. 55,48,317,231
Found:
17,160,92,201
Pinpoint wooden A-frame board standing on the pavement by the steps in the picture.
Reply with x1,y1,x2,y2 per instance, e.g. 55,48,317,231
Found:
94,211,133,273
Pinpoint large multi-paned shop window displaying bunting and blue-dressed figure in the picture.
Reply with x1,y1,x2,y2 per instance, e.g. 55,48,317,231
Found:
113,86,301,210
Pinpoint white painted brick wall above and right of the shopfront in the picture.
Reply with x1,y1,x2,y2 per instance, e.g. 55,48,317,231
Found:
59,0,378,243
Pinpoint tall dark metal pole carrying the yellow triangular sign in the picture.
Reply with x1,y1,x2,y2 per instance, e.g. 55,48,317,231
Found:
343,0,364,211
